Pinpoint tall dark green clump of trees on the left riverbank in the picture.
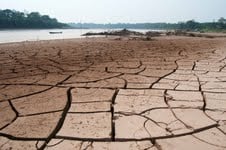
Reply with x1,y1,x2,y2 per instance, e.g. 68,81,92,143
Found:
0,9,68,29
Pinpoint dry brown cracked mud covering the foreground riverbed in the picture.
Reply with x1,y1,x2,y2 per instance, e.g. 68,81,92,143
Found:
0,37,226,150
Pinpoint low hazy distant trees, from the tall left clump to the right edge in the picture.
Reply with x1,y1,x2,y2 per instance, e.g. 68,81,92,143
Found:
69,17,226,31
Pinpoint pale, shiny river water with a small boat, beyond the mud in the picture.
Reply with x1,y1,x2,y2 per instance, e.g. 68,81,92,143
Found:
0,29,161,43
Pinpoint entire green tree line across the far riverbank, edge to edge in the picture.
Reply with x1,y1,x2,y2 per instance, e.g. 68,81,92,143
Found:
0,9,226,32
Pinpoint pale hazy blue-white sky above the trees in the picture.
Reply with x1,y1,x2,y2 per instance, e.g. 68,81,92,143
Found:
0,0,226,23
